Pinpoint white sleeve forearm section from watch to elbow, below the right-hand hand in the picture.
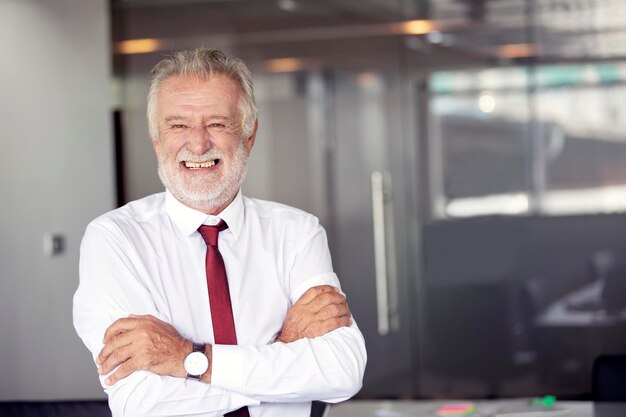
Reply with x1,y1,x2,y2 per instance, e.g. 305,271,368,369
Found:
211,316,366,403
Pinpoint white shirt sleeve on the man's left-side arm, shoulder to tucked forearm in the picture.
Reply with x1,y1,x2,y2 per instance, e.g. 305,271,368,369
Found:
73,219,259,417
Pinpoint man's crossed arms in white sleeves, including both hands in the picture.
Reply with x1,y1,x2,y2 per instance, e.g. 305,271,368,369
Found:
74,219,366,416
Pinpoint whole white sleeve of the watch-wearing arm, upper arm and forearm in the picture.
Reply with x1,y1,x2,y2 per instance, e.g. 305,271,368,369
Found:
211,216,367,402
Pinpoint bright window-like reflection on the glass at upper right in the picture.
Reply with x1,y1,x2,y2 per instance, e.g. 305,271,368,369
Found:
429,62,626,217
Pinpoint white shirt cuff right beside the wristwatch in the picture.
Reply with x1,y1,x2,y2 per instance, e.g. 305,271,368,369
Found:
211,345,246,395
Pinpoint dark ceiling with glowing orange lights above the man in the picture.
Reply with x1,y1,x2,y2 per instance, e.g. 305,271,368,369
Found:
112,0,626,71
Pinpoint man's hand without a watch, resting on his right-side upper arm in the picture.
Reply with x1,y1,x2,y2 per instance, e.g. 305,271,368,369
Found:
276,285,352,343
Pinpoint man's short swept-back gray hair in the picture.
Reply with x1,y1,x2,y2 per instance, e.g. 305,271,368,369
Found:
148,48,258,139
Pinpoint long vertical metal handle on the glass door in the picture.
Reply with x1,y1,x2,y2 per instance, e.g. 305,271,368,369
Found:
372,171,398,336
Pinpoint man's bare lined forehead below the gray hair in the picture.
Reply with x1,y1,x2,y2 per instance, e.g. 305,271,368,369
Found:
158,74,241,114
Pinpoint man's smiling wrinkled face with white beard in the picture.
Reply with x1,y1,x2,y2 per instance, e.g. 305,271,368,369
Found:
152,74,256,214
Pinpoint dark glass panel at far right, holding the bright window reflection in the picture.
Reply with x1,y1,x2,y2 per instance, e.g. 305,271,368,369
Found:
418,0,626,398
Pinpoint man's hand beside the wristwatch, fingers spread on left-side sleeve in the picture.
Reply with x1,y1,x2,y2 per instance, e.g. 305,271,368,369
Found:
96,315,192,385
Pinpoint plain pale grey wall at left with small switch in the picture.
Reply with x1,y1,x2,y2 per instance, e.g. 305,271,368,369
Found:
0,0,114,400
